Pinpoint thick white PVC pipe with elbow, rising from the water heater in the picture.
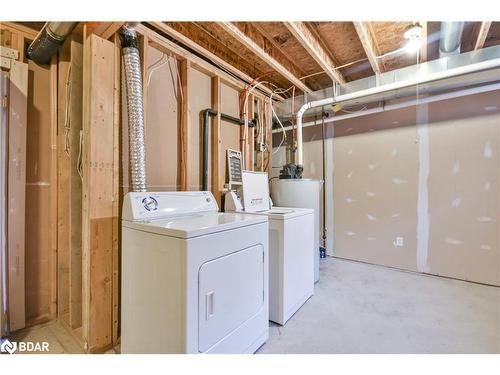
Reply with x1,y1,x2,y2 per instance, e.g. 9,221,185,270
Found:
296,58,500,167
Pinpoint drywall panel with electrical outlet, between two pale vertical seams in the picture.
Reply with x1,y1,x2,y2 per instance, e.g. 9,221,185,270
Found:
333,125,418,270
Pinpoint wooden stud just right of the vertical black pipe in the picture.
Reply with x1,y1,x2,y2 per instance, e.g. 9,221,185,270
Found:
211,76,224,207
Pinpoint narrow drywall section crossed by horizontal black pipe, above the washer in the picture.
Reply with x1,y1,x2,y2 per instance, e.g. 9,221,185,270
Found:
219,84,240,191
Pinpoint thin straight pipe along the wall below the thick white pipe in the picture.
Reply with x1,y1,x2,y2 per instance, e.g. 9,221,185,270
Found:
273,83,500,133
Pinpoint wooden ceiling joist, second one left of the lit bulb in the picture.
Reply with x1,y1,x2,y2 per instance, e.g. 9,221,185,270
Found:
284,22,345,83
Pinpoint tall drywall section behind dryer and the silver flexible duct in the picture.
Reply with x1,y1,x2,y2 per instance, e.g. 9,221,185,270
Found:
122,46,181,194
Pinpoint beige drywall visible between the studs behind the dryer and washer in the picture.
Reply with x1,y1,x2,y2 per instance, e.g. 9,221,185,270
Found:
121,46,240,200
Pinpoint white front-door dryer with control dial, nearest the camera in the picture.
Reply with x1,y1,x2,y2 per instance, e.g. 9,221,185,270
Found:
121,192,269,353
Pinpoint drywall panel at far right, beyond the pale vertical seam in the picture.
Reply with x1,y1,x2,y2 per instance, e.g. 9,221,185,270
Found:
428,93,500,285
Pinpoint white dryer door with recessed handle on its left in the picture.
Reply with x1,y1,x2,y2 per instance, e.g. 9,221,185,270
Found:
198,245,265,352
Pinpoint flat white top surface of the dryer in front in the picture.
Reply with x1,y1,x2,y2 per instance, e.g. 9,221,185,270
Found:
122,212,267,239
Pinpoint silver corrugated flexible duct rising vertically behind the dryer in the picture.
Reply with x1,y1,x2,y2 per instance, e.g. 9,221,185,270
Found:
120,25,146,192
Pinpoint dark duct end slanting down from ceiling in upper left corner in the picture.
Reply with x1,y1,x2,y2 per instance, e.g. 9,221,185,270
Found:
28,22,78,64
